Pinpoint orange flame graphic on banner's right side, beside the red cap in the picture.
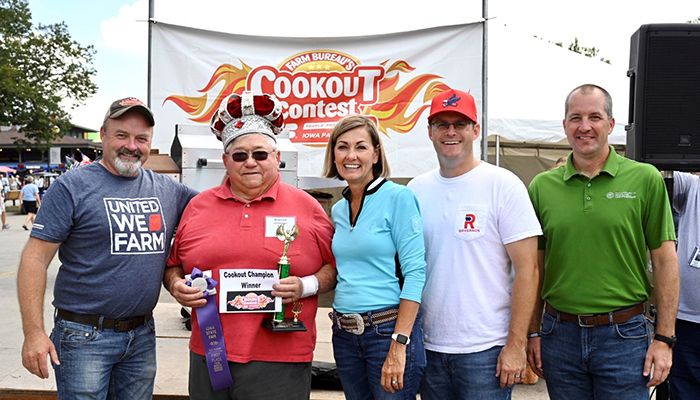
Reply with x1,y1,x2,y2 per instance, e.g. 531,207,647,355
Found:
362,60,449,136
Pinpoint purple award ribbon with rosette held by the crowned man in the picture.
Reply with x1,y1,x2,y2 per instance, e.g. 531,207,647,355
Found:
187,268,233,390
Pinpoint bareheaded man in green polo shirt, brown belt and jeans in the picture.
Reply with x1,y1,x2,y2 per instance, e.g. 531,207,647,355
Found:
528,85,678,400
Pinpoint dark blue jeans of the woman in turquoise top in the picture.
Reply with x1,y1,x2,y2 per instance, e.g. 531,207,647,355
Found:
333,310,425,400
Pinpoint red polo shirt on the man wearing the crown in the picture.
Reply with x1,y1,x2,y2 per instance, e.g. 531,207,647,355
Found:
167,178,335,363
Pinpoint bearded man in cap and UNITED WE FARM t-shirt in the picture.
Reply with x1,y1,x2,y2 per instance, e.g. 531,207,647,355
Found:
17,98,196,399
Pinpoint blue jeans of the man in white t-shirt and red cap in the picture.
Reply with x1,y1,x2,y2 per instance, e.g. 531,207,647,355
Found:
420,346,512,400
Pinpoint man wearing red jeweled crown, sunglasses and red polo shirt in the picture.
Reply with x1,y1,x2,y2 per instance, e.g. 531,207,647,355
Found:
164,92,336,399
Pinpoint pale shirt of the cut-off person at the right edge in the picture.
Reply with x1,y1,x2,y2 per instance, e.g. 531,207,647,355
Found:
673,172,700,323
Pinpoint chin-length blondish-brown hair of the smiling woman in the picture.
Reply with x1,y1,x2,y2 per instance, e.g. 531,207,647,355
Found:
323,115,389,179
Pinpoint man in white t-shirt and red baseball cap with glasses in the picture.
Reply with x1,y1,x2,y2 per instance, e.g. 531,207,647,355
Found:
408,89,542,400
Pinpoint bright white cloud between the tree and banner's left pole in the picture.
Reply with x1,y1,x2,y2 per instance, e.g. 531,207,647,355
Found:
100,0,148,56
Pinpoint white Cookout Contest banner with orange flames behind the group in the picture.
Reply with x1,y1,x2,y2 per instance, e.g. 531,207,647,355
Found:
151,23,482,177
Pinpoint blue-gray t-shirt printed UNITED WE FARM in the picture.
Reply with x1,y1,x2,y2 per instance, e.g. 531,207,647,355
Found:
31,163,196,318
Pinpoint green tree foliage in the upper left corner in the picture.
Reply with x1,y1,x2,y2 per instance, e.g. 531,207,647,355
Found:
0,0,97,145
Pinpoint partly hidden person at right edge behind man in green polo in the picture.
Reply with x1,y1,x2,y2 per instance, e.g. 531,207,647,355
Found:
669,172,700,400
